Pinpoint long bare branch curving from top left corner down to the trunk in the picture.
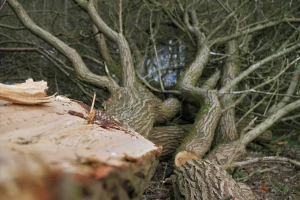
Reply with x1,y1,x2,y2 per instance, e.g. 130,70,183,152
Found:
7,0,119,92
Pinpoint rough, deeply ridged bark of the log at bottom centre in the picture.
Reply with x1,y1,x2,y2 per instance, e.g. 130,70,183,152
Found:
171,160,255,200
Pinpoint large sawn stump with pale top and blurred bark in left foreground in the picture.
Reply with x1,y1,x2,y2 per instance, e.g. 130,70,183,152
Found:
0,80,162,200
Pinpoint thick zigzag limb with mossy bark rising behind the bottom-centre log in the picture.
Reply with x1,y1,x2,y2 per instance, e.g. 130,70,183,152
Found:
175,8,221,158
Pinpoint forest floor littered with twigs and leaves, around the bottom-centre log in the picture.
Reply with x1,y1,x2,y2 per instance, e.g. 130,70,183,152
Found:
141,145,300,200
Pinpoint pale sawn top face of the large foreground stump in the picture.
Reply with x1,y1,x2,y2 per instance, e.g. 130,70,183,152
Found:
0,97,160,173
